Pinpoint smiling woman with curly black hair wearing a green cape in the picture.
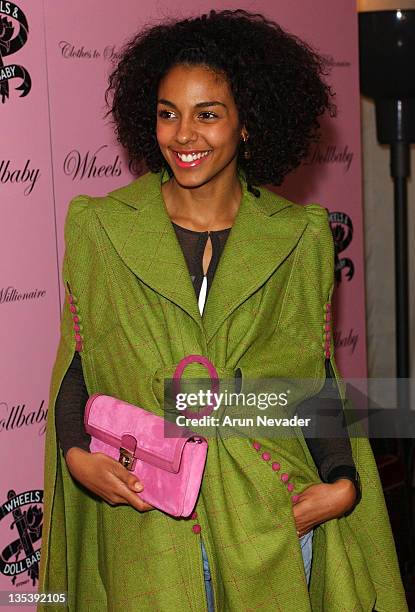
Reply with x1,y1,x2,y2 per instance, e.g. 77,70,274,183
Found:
39,10,406,612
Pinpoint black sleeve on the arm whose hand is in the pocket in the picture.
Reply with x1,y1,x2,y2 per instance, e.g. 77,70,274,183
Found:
298,364,356,482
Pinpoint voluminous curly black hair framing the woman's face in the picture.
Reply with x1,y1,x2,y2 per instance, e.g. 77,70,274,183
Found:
105,9,336,192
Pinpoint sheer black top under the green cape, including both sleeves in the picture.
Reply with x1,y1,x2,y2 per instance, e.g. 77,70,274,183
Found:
55,223,355,482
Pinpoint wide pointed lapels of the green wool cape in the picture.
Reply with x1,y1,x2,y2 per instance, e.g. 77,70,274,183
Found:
96,173,307,341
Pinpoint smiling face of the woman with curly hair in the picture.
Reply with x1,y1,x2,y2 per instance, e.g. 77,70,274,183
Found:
156,65,241,188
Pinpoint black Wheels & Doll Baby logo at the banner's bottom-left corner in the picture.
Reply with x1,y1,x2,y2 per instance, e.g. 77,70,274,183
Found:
0,489,43,586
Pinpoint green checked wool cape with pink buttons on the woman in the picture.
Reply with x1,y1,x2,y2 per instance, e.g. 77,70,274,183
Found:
38,173,407,612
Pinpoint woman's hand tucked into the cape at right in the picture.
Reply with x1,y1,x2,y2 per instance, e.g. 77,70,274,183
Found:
293,478,356,537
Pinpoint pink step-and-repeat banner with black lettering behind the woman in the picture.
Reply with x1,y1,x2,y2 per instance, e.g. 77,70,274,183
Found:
0,0,366,610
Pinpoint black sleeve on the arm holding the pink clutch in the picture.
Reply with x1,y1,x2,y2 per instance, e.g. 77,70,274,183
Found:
55,353,91,456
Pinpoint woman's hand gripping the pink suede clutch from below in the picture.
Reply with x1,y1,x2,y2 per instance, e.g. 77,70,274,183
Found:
65,446,154,512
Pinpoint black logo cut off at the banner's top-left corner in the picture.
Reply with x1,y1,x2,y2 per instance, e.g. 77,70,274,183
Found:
0,0,32,104
